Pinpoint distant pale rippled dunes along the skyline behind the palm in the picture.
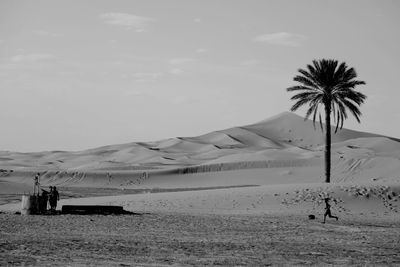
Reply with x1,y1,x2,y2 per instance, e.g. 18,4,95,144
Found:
0,112,400,171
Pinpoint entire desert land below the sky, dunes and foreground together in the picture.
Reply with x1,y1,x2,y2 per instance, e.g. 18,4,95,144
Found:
0,112,400,266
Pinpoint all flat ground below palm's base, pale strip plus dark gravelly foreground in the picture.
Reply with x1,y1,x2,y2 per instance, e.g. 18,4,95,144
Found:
0,183,400,266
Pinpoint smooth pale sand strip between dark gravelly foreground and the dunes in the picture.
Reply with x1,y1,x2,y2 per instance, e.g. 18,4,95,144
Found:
0,183,400,220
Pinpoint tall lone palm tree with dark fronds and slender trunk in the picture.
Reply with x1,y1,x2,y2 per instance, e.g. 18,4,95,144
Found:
286,59,366,183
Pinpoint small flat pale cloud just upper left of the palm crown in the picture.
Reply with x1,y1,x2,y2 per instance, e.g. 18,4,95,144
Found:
253,32,307,47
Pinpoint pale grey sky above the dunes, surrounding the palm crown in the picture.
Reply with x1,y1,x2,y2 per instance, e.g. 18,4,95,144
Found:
0,0,400,152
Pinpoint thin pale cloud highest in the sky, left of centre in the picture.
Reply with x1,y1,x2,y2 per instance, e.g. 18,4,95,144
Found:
100,13,155,32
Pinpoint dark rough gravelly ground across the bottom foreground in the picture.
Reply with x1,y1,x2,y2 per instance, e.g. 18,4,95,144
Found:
0,213,400,266
